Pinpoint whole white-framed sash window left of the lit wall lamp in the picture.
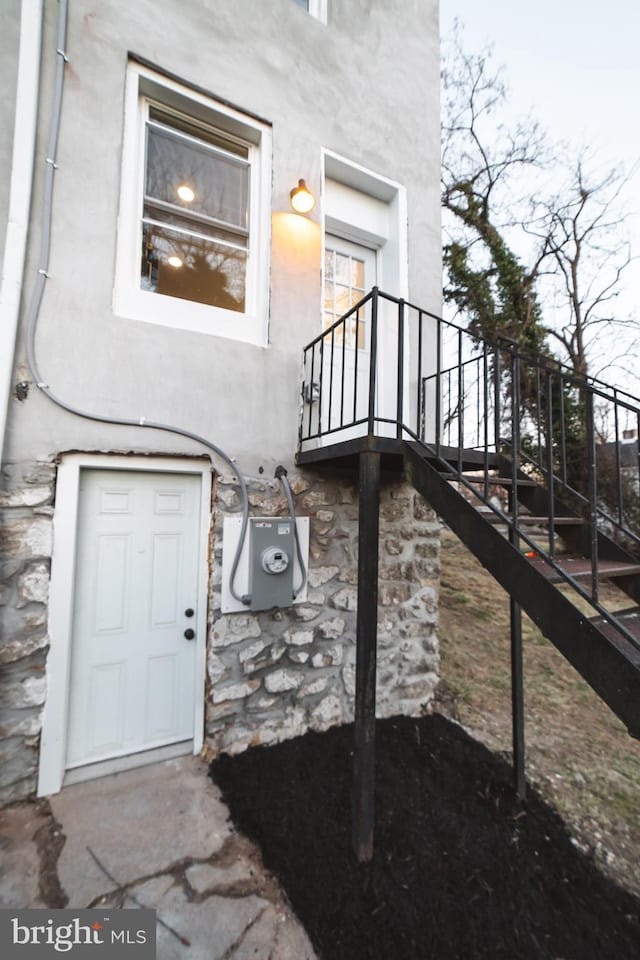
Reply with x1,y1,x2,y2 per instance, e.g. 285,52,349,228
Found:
114,65,269,344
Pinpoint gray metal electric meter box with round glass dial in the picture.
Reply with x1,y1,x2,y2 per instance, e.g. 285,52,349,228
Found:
249,517,296,610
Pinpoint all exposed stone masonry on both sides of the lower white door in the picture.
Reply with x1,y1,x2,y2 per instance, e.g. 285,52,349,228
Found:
0,462,439,805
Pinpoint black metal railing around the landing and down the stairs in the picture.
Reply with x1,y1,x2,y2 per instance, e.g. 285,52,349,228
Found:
299,287,640,646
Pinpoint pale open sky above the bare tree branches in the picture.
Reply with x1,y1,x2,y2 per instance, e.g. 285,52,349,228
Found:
440,0,640,380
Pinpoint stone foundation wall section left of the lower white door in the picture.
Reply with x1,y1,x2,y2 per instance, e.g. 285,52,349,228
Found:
0,463,55,804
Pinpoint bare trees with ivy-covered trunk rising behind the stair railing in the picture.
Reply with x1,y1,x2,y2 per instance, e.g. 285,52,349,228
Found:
441,25,637,384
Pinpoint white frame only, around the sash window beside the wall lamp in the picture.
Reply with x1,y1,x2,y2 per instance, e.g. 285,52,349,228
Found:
113,62,271,346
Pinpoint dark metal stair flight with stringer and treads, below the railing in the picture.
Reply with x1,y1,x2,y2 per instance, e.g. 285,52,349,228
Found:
405,443,640,737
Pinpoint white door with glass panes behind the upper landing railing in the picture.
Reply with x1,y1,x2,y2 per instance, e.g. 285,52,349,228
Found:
321,234,377,443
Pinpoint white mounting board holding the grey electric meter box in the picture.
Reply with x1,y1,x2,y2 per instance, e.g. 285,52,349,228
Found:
221,517,309,613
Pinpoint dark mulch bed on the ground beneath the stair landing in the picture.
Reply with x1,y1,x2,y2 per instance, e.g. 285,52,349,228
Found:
211,715,640,960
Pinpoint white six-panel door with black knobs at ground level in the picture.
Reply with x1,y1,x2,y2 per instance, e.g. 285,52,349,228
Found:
67,470,204,768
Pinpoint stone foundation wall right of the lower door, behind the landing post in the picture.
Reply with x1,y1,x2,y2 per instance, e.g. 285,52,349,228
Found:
206,472,439,755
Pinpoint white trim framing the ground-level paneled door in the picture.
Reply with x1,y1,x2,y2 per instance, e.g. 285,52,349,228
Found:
38,453,212,797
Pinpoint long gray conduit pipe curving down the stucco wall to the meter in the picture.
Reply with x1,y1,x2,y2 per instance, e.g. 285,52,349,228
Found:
21,0,250,605
